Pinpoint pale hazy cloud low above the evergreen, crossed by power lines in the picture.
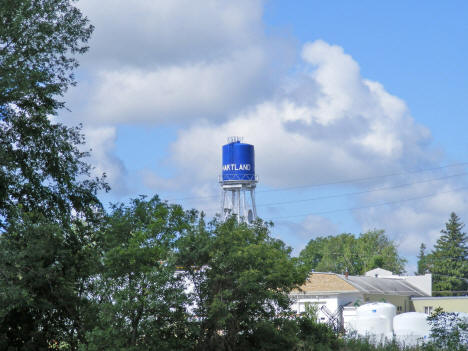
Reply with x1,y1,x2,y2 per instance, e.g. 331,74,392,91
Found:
355,177,468,256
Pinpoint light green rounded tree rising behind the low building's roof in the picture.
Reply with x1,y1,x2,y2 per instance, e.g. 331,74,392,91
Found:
299,230,406,275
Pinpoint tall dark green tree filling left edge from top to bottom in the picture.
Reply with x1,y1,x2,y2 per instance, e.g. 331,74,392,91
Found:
0,0,108,350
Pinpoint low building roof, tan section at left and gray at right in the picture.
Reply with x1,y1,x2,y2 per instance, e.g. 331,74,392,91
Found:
291,272,427,296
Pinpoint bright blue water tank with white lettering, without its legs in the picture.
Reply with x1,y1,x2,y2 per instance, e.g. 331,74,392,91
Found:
223,141,255,181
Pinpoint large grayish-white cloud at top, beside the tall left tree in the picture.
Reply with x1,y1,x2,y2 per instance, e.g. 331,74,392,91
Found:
68,0,294,125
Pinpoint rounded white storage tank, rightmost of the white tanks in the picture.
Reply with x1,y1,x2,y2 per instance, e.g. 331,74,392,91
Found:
393,312,431,346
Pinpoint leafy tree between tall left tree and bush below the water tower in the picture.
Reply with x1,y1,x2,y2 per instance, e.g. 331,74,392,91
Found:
82,197,195,350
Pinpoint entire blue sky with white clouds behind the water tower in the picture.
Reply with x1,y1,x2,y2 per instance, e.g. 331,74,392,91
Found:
59,0,468,273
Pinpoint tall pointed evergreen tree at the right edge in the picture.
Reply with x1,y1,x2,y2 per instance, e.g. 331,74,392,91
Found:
428,212,468,292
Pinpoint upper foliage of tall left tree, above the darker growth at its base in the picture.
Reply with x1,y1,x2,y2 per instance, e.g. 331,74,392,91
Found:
0,0,103,230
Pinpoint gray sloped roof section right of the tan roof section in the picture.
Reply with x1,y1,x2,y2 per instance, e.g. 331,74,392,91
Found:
339,274,427,296
